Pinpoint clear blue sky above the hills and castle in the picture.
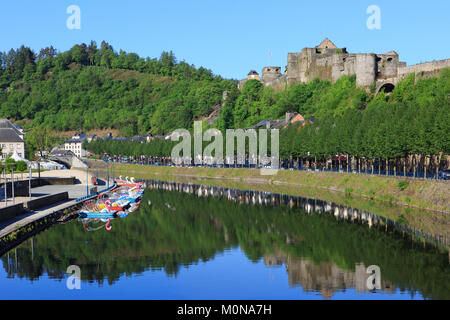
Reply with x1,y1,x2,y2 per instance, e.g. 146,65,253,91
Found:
0,0,450,79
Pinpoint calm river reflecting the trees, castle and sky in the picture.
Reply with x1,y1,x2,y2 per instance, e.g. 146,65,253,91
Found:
0,183,450,300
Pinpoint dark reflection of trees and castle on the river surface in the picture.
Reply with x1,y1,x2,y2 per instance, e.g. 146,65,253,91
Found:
2,181,450,299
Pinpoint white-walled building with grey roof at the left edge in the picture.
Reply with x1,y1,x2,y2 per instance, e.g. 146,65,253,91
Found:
0,119,25,160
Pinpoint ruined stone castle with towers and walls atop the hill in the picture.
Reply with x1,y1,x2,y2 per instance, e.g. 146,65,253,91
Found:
239,38,450,92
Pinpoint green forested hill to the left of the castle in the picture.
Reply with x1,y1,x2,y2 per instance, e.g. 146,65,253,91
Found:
0,42,236,136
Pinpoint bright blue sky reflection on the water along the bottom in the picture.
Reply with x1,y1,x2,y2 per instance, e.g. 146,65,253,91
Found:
0,248,423,300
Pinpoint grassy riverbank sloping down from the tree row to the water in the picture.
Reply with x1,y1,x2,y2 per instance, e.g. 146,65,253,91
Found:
110,165,450,214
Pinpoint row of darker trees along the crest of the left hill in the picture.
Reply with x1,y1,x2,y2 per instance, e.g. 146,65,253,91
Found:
0,41,222,86
